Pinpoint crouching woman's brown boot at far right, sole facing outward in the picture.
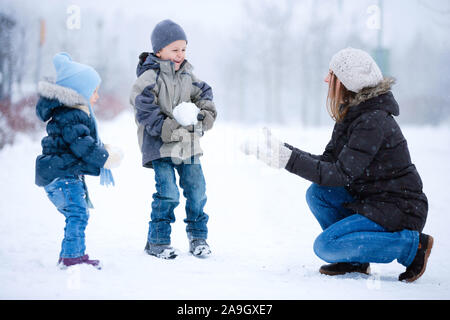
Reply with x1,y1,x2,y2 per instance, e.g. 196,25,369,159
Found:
398,233,434,282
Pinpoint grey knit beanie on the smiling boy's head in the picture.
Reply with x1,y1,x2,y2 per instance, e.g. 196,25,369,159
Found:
151,19,187,53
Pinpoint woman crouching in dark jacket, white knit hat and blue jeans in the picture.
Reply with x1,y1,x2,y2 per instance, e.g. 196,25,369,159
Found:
244,48,433,282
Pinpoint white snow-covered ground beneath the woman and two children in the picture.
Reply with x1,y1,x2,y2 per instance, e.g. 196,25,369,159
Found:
0,113,450,300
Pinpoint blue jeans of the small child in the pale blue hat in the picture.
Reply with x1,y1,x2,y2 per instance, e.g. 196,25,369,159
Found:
44,178,89,258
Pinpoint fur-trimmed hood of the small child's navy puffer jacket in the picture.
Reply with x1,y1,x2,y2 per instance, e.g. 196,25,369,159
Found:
36,81,88,122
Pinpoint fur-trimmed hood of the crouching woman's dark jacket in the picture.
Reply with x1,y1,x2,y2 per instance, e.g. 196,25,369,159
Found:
348,78,400,116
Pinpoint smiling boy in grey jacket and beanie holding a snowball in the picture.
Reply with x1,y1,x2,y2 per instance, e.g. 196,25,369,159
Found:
130,20,217,259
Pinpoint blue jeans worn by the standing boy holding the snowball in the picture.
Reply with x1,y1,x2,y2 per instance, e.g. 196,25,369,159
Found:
148,158,208,244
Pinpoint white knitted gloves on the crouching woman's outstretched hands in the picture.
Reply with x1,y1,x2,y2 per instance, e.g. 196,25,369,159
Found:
241,128,292,169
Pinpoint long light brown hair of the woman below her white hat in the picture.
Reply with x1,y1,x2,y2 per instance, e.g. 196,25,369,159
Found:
327,71,356,122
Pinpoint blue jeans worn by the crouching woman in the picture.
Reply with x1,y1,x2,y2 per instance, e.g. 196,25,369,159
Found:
306,184,419,267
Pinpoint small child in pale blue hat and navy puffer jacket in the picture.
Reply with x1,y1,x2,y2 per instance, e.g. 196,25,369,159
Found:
36,53,122,269
